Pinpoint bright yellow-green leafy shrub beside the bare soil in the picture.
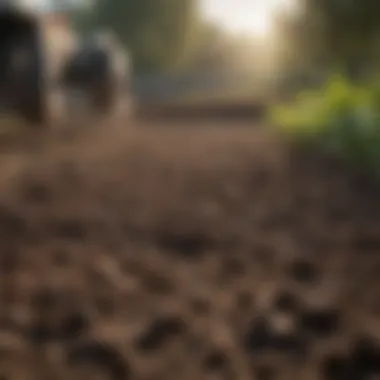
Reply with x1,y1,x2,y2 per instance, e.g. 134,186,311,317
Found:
269,75,380,179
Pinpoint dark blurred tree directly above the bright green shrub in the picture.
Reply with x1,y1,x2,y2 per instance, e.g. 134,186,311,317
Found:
277,0,380,78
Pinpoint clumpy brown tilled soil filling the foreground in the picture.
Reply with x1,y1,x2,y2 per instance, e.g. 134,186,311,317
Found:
0,121,380,380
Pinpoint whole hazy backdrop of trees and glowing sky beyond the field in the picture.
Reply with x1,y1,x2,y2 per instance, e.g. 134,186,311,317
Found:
49,0,380,102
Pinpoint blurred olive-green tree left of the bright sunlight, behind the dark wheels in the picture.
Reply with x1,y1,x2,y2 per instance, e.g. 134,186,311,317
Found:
76,0,199,71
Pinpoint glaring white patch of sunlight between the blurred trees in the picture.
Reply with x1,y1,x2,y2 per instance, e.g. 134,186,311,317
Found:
201,0,289,37
